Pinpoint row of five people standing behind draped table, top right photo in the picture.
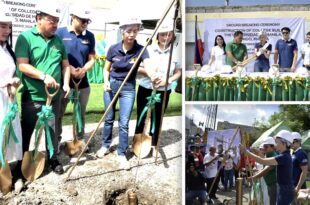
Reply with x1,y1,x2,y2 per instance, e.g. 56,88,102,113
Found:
202,27,310,72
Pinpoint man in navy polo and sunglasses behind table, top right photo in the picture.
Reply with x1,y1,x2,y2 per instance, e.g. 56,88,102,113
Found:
274,27,298,72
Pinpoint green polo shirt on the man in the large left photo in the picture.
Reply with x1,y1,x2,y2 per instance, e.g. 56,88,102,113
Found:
15,26,68,101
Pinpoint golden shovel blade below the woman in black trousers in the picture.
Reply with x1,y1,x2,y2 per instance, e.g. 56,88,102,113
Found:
132,133,152,158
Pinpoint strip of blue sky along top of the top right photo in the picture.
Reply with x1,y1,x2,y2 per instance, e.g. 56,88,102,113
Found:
185,0,310,7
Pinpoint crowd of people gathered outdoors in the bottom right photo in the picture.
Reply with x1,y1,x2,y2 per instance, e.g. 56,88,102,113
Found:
186,130,310,205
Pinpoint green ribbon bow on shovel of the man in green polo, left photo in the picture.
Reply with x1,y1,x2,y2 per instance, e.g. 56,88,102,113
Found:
33,105,55,159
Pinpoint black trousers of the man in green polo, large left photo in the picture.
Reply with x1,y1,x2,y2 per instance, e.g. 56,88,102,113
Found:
21,94,60,159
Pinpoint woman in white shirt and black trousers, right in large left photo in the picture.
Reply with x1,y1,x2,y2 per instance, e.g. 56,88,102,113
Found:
135,19,181,154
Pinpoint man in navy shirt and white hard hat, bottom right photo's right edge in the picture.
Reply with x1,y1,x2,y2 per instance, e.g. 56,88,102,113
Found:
291,132,308,204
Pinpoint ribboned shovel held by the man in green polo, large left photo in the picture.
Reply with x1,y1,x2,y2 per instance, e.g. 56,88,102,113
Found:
22,86,59,181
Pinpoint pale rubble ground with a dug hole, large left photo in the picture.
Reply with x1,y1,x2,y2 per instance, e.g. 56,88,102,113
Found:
0,117,182,205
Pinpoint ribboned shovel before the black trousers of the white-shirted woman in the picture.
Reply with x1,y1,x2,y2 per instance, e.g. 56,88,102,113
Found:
132,90,160,158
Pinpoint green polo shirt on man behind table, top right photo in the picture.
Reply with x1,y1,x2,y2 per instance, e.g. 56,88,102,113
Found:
225,41,247,67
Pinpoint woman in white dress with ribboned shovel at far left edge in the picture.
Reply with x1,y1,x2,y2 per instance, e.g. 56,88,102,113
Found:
0,3,23,193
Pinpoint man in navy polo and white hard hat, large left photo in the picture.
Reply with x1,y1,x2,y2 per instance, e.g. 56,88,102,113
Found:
56,4,95,148
